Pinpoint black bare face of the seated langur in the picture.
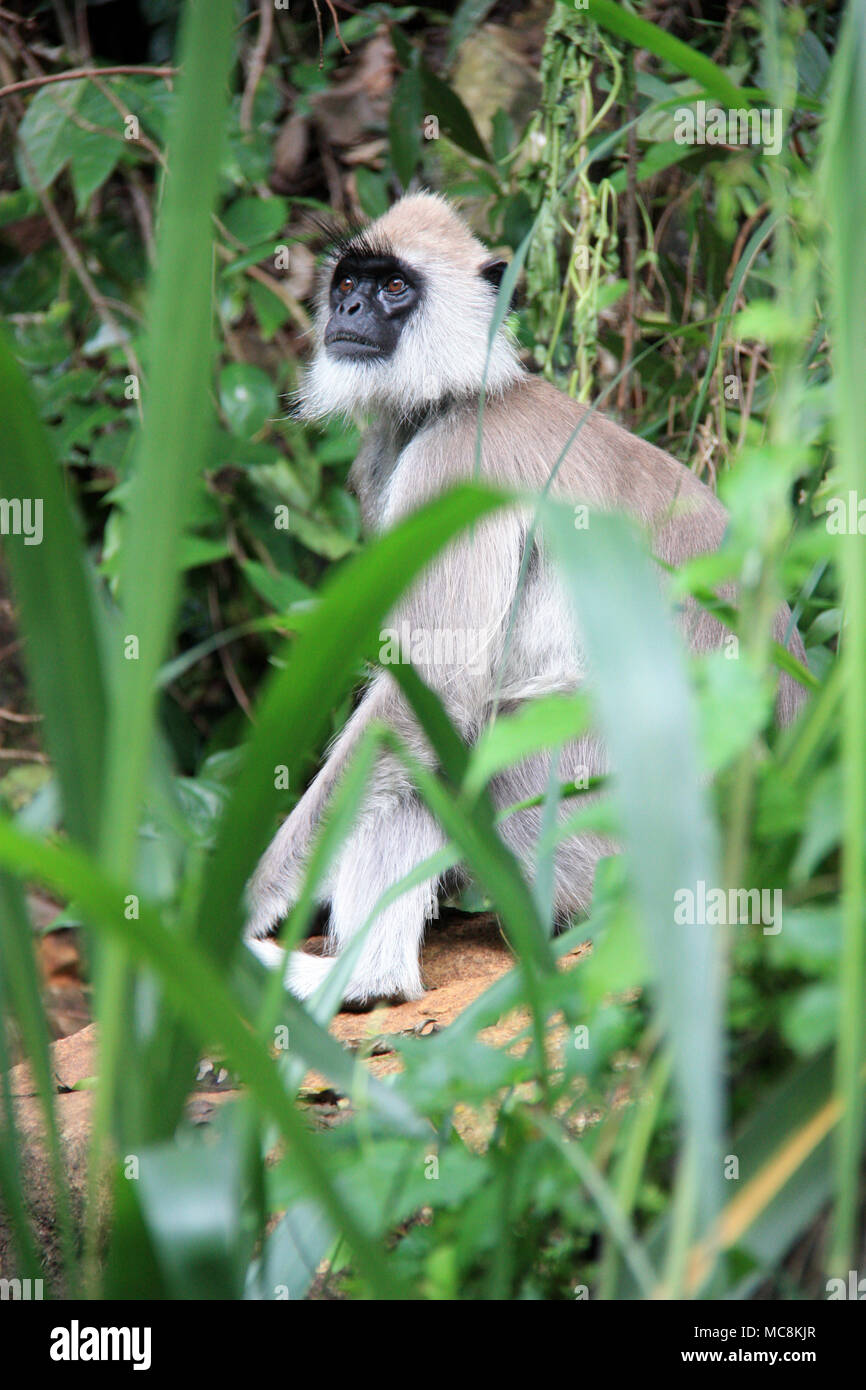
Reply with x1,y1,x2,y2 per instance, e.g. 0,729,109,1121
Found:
325,252,424,361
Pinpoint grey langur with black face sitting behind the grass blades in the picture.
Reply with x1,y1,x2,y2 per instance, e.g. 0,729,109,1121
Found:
246,193,805,1006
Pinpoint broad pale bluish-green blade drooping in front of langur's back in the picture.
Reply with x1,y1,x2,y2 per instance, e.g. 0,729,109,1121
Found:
541,503,723,1262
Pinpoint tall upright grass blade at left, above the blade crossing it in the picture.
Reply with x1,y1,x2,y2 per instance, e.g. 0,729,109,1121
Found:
103,0,235,874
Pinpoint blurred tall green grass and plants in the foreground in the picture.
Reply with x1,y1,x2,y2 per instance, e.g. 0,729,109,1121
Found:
0,0,866,1298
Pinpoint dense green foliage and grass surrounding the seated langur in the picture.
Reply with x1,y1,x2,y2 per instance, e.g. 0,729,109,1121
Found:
0,0,866,1298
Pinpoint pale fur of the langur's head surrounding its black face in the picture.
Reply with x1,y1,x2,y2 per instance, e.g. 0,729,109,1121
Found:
297,193,523,421
